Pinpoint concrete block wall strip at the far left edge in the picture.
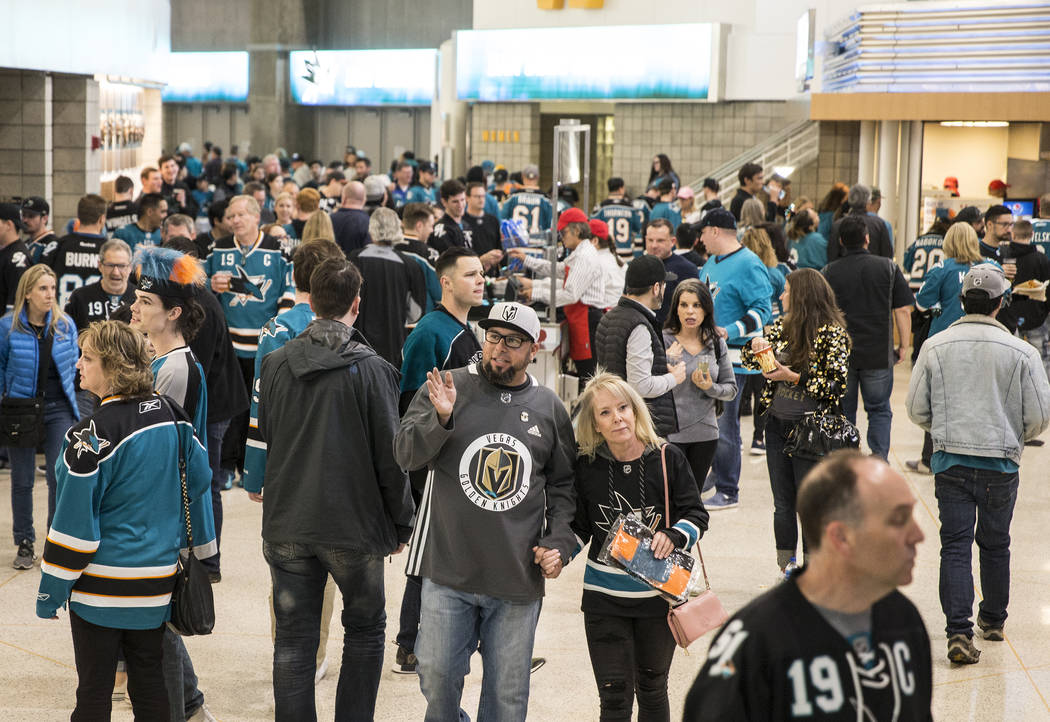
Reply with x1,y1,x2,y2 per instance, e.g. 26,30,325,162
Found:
0,69,53,199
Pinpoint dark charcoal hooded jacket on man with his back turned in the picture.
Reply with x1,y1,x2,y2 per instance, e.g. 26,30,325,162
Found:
258,318,415,554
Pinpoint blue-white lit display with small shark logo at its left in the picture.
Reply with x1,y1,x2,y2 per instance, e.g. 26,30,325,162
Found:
288,49,438,106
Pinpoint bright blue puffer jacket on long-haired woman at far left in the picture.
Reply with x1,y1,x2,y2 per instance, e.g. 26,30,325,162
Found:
0,309,80,421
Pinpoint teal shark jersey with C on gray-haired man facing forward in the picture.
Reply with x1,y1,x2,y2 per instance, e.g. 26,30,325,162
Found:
205,231,295,359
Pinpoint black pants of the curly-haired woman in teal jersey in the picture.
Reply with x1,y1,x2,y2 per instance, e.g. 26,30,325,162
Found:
69,610,171,722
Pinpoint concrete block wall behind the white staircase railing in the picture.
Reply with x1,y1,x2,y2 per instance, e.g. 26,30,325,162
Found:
612,101,805,195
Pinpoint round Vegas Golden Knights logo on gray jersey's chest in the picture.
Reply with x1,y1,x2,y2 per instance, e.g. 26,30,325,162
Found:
459,433,532,511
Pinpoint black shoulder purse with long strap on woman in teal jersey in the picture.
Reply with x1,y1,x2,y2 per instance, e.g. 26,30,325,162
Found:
163,399,215,637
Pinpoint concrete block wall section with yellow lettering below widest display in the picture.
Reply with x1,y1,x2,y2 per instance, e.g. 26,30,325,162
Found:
467,103,550,177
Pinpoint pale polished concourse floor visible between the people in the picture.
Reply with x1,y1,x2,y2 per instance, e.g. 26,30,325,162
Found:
0,368,1050,722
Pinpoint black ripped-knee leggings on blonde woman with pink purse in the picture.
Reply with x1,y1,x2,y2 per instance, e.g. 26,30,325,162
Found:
584,612,674,722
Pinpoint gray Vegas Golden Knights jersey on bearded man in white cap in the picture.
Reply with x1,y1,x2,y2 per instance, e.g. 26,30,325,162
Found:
394,364,576,601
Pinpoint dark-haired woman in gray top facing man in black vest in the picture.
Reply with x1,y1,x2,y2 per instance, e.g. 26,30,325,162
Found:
664,278,737,491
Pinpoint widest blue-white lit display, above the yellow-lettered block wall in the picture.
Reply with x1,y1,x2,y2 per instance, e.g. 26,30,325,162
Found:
456,23,717,101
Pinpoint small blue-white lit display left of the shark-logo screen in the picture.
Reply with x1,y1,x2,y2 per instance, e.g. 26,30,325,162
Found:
161,51,248,103
